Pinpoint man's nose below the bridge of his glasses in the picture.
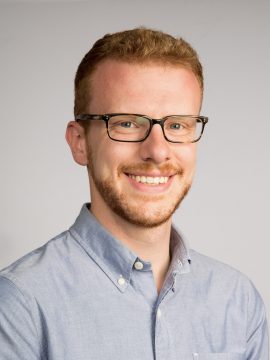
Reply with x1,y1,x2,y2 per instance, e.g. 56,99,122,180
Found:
140,124,171,164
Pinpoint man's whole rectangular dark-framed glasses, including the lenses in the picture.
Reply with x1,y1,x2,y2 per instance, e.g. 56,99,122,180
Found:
75,114,208,144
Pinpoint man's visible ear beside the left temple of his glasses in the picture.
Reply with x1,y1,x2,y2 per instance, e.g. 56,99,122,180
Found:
66,121,88,166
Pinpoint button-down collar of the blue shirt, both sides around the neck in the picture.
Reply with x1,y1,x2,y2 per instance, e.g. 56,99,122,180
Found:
69,204,190,292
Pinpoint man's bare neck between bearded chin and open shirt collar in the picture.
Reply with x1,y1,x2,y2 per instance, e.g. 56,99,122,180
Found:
91,203,171,292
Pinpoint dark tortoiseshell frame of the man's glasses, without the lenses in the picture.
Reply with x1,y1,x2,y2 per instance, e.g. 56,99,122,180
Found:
75,113,208,144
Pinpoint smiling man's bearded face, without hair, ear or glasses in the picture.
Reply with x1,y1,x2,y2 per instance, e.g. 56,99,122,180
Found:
87,60,201,227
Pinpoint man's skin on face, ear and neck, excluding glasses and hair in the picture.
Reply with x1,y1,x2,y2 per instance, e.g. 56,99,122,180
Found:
66,60,202,292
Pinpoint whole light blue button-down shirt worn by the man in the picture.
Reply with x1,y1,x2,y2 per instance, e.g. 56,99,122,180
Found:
0,206,268,360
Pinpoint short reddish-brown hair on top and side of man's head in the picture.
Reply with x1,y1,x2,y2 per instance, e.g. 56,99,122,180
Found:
74,27,203,115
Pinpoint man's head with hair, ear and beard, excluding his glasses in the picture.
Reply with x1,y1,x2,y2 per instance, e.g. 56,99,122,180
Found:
67,29,206,227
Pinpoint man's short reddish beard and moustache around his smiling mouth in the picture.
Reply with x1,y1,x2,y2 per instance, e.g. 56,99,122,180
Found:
89,152,191,228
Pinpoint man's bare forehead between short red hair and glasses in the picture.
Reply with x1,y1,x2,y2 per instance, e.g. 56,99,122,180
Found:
90,60,201,113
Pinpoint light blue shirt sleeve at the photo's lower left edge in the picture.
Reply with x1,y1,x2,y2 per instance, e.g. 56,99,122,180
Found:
0,276,41,360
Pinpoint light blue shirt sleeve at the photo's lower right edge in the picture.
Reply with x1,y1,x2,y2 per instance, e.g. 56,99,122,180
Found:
246,285,269,360
